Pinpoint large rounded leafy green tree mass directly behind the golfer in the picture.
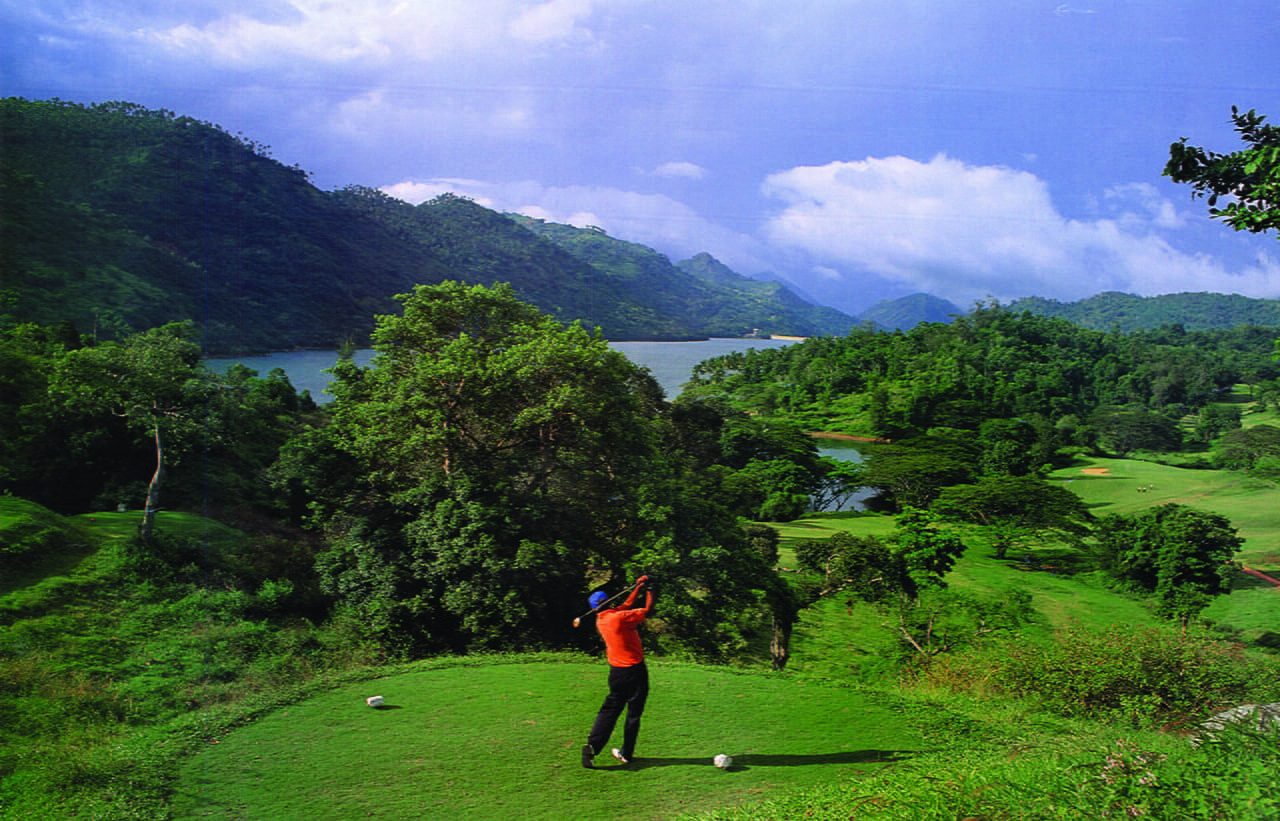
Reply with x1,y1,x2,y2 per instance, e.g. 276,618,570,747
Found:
302,282,771,653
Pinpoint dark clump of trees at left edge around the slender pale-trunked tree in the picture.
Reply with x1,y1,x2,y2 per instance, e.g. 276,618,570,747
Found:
0,323,315,515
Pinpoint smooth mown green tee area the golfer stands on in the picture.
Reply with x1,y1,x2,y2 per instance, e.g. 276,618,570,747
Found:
174,661,929,821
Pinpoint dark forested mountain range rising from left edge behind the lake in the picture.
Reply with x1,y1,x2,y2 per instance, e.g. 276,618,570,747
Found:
0,99,852,354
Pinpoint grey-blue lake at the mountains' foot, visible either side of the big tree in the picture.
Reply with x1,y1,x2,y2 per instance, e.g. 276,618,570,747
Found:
205,339,794,402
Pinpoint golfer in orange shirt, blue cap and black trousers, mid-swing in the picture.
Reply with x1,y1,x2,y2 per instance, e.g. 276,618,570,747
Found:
582,576,653,767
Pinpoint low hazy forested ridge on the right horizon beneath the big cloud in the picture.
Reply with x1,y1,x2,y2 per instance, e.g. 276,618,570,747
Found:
1009,291,1280,333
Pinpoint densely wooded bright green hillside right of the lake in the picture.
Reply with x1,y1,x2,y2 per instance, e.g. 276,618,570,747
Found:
692,305,1280,452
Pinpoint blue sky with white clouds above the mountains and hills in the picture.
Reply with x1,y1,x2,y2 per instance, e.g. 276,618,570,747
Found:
0,0,1280,313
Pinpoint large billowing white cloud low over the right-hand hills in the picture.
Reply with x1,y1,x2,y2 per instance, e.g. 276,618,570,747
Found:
763,155,1280,304
